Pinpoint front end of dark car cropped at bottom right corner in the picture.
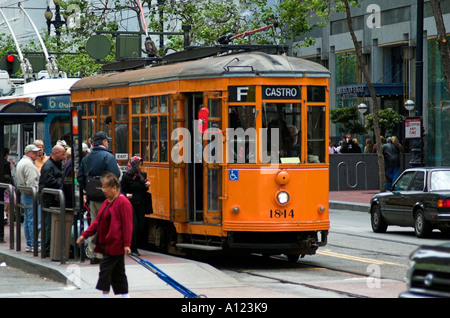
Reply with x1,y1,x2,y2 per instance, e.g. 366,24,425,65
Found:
400,243,450,298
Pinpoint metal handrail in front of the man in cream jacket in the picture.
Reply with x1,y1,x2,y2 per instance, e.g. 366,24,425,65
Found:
16,186,39,256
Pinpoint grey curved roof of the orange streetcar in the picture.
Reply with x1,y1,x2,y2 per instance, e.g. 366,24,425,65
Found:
71,52,330,91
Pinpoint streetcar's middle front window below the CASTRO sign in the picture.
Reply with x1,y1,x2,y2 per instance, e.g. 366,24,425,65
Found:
262,103,301,163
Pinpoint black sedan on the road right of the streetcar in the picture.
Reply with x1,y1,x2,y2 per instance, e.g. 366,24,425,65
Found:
370,167,450,237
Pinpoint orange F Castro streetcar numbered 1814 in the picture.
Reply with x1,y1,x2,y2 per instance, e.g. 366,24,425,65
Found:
71,52,330,260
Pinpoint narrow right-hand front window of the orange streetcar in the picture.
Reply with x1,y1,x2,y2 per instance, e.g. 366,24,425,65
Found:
307,106,326,163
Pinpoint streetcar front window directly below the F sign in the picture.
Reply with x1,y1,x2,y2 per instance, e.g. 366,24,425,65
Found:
227,106,256,163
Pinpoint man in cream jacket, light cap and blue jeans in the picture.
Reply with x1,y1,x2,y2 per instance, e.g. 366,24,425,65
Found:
16,144,40,252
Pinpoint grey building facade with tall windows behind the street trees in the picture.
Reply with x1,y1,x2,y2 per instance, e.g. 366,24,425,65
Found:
292,0,450,166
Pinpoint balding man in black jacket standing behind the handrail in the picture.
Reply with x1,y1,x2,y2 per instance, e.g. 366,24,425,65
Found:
39,145,66,255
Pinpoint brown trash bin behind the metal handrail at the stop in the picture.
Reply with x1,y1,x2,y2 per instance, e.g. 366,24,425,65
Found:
48,209,73,261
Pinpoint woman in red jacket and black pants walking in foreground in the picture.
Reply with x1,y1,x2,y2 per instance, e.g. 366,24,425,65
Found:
77,172,133,297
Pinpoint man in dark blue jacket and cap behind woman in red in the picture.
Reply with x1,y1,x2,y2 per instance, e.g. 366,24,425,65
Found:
77,131,120,264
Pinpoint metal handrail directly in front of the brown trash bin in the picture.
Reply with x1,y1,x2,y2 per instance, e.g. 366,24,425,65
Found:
40,189,66,264
